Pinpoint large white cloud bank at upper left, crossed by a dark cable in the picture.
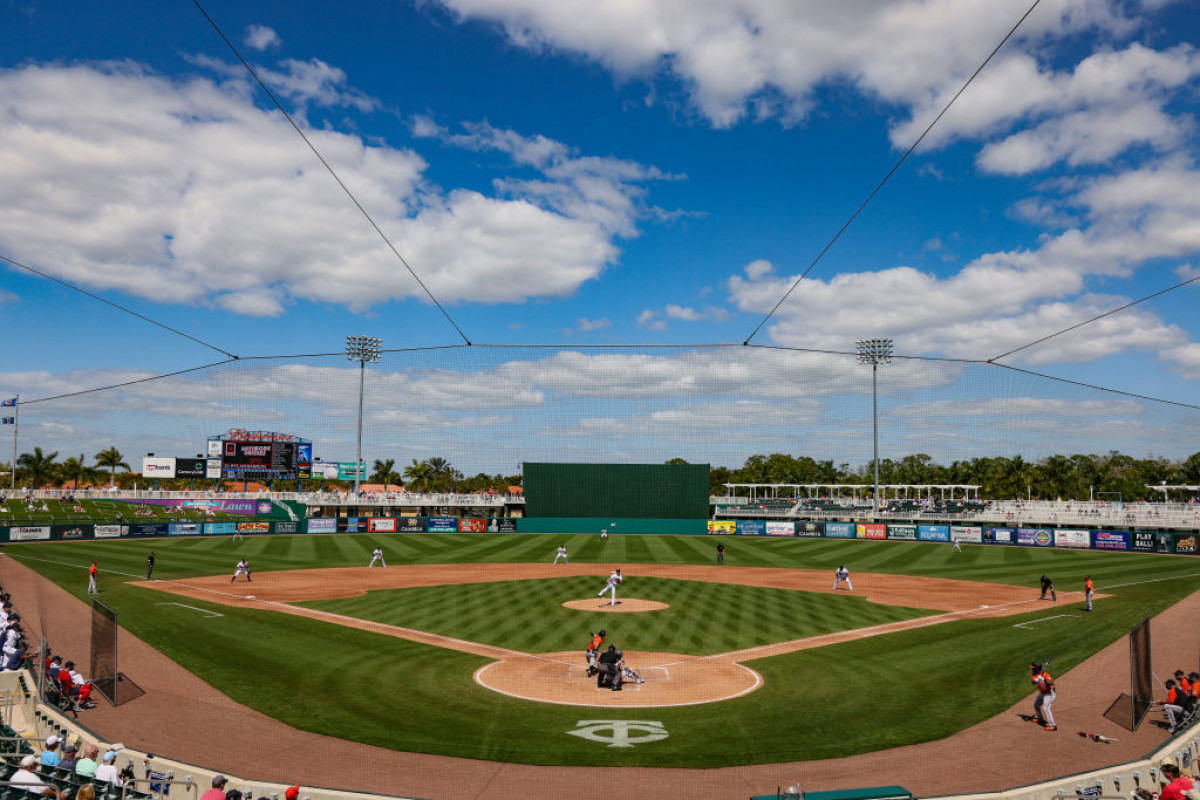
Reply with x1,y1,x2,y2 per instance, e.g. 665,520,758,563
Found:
0,61,659,315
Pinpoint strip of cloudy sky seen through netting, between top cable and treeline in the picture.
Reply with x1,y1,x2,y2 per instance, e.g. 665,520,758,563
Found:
20,345,1200,475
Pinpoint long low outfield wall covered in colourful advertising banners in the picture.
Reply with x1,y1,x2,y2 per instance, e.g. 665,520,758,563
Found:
0,517,1200,555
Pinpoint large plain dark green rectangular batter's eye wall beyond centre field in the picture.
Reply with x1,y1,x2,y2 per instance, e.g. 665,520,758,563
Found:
522,462,708,519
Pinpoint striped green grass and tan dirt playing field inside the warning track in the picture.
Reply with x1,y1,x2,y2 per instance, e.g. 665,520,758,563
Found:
4,534,1200,768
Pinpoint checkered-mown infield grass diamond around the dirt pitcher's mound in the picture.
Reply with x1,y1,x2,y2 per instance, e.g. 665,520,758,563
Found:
300,577,935,655
